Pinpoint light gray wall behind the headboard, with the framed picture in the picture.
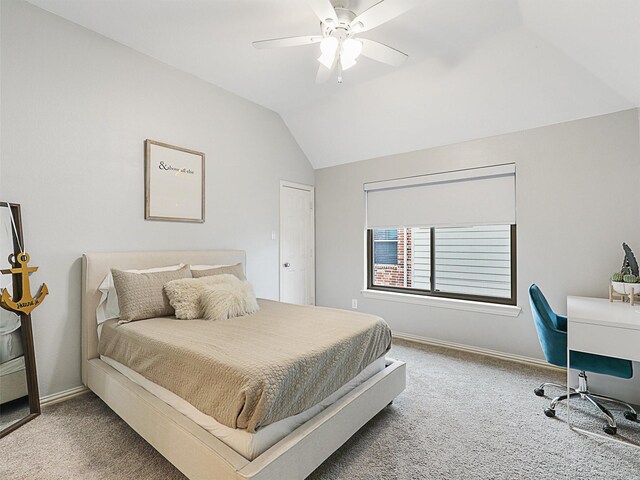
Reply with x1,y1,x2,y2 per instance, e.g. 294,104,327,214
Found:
0,0,314,395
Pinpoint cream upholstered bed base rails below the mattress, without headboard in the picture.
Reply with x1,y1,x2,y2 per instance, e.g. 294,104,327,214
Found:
87,359,406,480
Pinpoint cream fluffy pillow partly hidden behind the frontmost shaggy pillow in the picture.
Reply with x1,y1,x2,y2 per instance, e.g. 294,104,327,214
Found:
164,274,240,320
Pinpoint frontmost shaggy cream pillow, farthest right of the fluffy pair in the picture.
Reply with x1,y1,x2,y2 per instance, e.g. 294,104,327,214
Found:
200,280,260,320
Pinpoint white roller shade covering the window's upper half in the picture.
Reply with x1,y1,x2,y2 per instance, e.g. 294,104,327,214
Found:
364,163,516,228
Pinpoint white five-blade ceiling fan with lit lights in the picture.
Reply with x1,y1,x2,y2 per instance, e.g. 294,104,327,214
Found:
253,0,415,83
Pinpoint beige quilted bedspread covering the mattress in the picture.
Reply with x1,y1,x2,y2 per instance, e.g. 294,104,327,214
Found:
99,299,391,432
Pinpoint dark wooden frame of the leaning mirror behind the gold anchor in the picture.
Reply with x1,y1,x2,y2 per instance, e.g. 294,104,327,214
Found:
0,202,40,438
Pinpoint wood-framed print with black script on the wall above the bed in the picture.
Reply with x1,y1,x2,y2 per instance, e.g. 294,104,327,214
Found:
144,139,205,223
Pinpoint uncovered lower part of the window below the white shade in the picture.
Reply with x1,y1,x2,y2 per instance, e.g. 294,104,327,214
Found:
367,225,516,305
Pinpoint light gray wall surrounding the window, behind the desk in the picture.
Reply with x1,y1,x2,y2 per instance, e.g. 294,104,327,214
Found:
316,110,640,400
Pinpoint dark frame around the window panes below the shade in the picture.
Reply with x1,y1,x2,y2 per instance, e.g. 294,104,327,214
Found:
366,224,518,306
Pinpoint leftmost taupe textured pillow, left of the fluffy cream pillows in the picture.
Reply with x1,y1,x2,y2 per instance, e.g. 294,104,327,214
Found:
111,265,191,323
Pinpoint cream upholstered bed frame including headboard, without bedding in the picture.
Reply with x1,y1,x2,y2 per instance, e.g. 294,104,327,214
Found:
82,250,405,480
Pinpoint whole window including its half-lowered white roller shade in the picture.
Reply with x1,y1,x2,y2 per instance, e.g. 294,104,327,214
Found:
364,164,516,305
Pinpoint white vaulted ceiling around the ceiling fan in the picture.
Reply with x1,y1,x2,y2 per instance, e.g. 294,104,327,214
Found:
23,0,640,168
